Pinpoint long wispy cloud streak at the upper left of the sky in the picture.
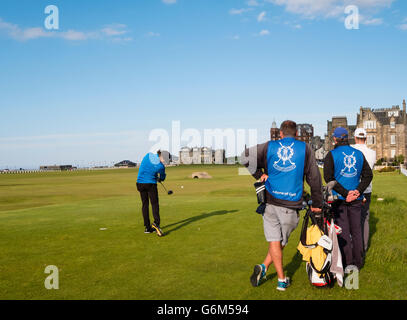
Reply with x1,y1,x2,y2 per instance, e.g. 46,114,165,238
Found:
0,18,131,41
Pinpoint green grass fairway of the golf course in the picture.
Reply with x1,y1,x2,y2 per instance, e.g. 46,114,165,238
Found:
0,166,407,300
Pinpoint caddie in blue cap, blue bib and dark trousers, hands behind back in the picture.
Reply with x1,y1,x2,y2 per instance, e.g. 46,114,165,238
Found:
324,127,373,270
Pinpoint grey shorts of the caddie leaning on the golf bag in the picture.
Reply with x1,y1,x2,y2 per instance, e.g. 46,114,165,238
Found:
263,204,300,246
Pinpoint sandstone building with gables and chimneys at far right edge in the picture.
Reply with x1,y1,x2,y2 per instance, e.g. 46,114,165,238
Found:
357,100,407,160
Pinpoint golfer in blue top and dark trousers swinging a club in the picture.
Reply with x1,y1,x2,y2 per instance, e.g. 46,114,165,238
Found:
137,151,166,237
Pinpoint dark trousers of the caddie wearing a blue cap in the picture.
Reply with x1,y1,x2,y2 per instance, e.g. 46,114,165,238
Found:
333,201,364,269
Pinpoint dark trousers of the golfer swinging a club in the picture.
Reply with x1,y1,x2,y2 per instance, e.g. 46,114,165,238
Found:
137,183,160,228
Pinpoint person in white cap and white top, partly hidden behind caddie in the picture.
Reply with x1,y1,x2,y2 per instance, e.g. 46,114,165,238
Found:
352,128,376,253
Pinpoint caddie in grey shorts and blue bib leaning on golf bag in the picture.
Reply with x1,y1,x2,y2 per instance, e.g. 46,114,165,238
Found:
241,121,322,291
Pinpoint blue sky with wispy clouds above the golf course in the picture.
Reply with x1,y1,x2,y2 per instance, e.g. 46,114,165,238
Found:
0,0,407,169
